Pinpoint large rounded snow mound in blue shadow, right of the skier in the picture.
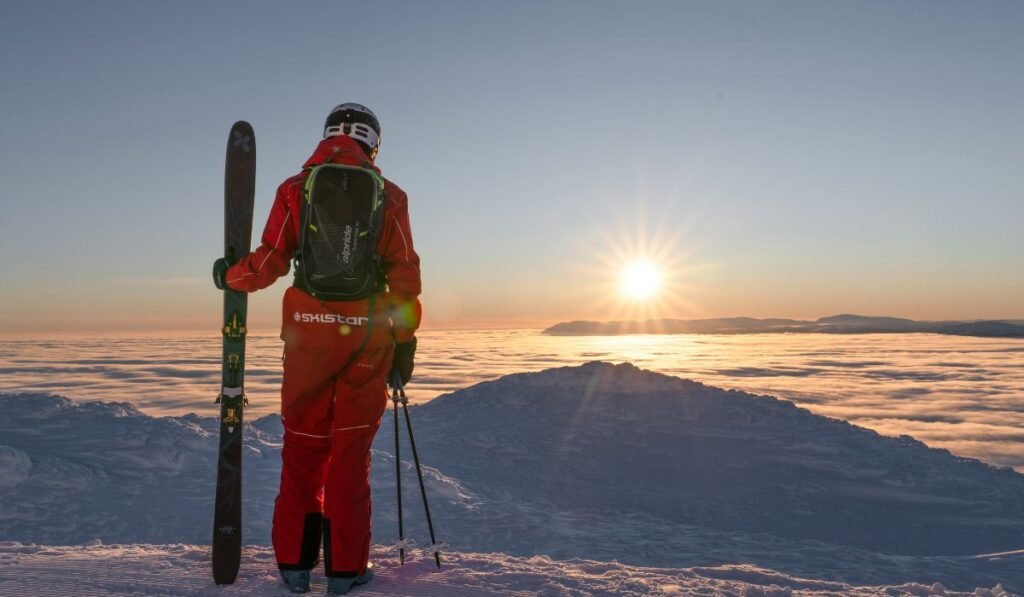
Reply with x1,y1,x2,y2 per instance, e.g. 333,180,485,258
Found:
407,363,1024,556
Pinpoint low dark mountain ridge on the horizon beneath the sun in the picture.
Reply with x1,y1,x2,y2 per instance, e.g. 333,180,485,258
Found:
544,314,1024,338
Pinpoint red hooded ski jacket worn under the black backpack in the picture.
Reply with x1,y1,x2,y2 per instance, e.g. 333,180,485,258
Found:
225,135,422,342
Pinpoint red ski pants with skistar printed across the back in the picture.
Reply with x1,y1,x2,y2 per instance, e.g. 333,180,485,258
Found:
272,288,393,577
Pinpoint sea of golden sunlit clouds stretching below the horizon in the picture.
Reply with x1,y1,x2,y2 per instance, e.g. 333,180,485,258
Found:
0,330,1024,470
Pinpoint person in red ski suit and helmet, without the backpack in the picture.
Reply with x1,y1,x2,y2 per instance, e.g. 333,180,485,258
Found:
214,103,421,593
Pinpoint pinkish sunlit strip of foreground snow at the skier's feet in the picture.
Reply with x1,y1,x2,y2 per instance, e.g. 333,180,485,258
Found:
0,543,1011,597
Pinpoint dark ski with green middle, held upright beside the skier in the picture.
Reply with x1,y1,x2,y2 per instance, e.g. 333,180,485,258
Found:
212,121,256,585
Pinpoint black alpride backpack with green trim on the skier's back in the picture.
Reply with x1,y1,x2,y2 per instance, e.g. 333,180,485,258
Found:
295,164,387,301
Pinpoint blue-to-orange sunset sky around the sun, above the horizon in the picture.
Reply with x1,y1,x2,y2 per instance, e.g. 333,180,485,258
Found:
0,1,1024,333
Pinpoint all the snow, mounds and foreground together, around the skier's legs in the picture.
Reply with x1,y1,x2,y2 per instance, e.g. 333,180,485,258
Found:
0,363,1024,595
